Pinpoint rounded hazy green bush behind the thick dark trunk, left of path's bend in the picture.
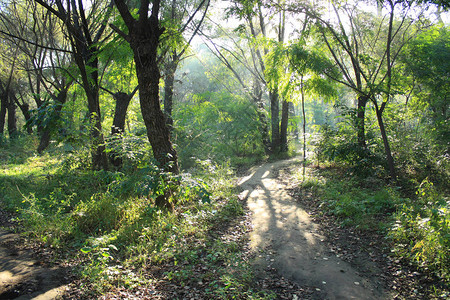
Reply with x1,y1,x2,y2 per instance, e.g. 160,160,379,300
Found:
174,92,263,169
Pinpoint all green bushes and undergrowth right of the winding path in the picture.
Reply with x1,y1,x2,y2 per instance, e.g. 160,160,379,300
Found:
295,99,450,299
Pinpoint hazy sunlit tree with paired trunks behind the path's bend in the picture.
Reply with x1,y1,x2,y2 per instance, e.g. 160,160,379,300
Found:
210,1,289,153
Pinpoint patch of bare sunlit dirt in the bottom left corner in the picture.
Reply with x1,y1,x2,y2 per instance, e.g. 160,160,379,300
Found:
0,225,66,300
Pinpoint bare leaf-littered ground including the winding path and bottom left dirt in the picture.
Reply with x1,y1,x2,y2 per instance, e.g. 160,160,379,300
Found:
0,159,445,299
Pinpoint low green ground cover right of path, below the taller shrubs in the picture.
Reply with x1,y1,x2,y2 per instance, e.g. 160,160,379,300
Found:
295,167,450,298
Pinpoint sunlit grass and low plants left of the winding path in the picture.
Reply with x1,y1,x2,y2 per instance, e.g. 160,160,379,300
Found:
0,140,273,299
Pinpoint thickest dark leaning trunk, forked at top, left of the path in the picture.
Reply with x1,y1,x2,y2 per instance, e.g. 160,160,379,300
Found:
114,0,179,210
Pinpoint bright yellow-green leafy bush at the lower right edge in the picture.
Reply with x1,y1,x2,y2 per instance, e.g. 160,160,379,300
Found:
390,179,450,283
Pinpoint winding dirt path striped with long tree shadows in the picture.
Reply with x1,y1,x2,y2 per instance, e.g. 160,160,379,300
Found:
239,159,389,300
